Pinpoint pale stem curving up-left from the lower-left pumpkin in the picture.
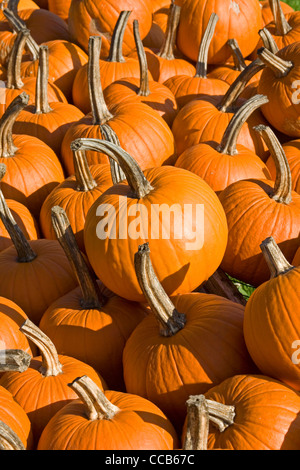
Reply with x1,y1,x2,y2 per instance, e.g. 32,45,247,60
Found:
20,319,62,377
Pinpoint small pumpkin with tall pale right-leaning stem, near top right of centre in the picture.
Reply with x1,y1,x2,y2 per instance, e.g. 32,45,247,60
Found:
164,13,229,108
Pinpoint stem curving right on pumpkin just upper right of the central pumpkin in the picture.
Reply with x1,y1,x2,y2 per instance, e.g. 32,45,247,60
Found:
217,95,269,155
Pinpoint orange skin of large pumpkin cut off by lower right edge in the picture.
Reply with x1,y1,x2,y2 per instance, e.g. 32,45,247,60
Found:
244,268,300,391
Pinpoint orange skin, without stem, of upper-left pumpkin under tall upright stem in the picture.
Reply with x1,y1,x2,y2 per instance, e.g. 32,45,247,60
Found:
14,102,84,155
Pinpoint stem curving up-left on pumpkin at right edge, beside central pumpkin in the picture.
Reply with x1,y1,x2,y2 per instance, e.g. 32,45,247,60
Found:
254,124,293,204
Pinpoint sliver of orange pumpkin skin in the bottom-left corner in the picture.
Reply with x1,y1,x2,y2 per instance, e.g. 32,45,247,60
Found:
0,386,33,450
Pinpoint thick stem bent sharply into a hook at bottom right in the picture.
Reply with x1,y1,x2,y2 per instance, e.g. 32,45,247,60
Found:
183,395,235,450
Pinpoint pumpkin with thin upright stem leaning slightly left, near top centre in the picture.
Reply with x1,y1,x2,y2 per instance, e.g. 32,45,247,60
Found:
104,20,177,127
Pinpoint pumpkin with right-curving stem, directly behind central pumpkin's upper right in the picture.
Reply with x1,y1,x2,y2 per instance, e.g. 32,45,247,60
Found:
175,95,271,193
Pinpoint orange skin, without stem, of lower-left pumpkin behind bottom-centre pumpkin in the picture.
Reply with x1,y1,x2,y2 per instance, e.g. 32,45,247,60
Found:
0,355,105,446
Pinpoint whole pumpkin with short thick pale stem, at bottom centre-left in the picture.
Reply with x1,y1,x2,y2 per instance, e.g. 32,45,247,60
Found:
38,376,178,451
